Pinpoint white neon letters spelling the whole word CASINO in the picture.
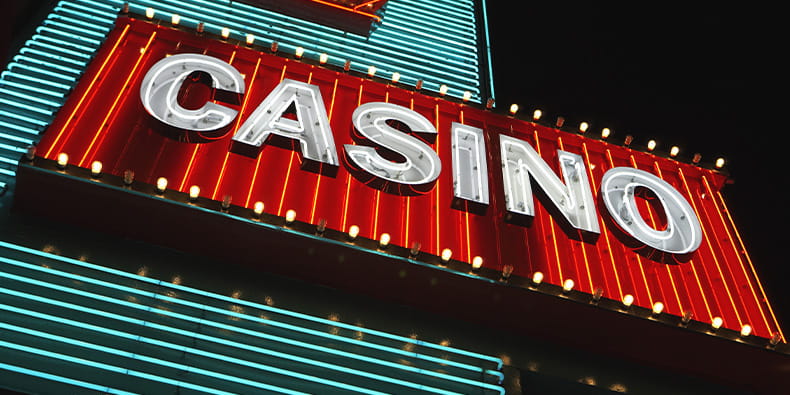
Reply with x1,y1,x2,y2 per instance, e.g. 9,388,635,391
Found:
140,54,702,254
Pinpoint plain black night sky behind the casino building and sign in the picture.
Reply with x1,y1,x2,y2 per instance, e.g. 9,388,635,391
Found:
0,0,790,334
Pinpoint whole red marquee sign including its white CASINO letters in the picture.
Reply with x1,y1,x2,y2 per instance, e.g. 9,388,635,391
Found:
27,18,778,337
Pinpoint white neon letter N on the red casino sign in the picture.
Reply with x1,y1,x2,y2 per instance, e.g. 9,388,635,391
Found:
499,135,601,234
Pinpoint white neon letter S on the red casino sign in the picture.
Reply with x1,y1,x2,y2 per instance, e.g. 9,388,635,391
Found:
345,102,442,185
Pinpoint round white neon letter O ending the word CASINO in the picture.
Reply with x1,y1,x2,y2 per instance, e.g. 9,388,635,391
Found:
601,167,702,254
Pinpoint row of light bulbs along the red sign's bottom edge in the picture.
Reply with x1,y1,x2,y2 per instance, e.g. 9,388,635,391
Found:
52,151,780,347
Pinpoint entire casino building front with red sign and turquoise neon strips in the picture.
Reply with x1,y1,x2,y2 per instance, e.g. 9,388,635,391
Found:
0,0,790,393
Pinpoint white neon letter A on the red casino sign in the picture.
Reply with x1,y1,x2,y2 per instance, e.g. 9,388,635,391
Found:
233,79,338,166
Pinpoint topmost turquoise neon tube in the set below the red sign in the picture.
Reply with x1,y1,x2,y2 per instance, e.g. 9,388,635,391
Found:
0,241,502,370
